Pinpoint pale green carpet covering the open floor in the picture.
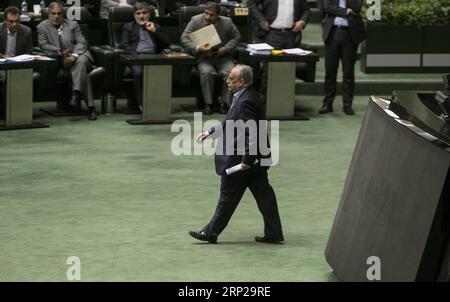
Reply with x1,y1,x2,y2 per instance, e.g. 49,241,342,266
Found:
0,96,368,281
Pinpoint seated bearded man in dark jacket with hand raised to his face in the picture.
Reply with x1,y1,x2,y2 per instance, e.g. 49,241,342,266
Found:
120,2,169,111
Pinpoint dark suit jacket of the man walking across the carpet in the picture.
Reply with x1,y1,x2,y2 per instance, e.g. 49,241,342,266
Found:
209,86,270,175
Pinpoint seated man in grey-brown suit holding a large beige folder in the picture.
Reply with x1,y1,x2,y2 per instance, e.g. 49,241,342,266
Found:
181,2,241,115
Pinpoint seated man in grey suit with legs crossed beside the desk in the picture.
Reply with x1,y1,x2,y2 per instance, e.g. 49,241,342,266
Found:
37,2,97,120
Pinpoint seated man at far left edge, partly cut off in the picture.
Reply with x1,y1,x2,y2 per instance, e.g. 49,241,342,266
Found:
0,6,33,119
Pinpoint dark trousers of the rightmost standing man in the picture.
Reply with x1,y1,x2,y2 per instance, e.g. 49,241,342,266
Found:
323,27,358,106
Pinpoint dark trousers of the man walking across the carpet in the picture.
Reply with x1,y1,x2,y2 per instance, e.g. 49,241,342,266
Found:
202,166,283,238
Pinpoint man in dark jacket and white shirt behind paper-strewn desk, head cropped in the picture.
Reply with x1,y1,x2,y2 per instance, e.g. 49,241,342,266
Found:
247,0,311,49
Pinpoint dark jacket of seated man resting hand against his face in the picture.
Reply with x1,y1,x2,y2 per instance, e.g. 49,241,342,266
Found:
120,21,170,53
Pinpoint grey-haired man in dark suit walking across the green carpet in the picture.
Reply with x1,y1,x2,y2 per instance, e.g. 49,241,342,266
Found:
189,65,284,243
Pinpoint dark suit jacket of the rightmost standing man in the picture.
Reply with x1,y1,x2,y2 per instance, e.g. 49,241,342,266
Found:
321,0,366,44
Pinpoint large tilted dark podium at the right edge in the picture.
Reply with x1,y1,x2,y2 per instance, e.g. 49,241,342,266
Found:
325,91,450,281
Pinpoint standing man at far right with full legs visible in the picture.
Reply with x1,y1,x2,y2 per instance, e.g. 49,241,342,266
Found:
319,0,366,115
